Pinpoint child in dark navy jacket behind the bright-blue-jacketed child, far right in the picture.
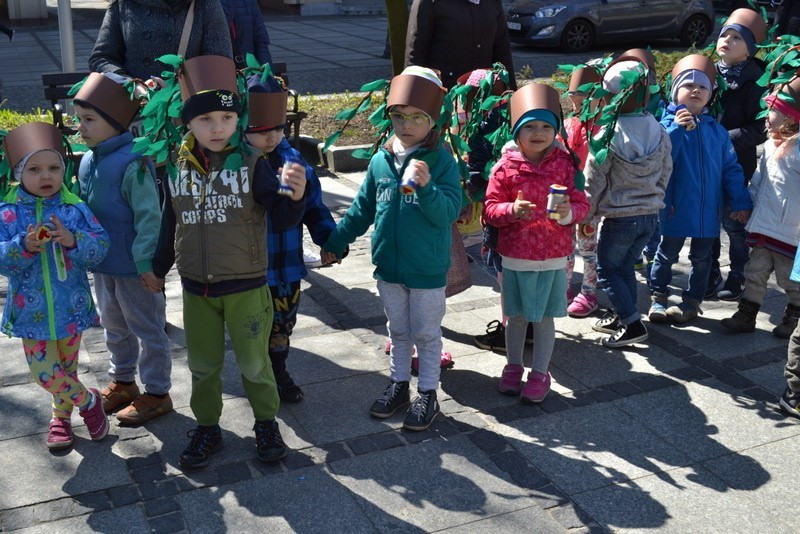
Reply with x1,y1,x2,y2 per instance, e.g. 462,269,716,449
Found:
706,8,767,301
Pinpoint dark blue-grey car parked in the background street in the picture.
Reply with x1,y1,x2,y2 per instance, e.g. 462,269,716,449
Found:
507,0,714,52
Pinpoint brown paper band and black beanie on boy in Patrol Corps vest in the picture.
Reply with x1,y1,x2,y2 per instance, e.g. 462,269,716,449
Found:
178,56,242,124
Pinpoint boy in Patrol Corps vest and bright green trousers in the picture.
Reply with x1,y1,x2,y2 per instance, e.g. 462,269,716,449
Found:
145,56,305,469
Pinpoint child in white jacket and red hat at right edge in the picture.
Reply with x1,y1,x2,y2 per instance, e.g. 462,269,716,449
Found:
722,77,800,338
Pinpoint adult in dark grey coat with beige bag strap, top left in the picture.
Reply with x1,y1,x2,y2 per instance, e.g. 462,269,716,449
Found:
89,0,233,80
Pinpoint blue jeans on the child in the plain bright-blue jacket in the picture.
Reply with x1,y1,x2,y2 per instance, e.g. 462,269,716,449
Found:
650,236,715,304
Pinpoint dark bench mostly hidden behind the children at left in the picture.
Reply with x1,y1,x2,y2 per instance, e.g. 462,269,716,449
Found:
42,63,308,149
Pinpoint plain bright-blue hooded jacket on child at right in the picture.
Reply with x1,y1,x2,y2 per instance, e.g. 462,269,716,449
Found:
659,104,753,237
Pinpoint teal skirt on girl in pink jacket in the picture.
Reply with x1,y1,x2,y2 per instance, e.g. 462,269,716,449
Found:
502,268,567,323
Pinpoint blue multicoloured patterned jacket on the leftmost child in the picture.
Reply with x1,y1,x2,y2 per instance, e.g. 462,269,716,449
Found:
0,188,109,340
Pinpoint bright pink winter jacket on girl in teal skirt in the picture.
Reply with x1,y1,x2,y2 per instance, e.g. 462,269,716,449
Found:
483,143,589,261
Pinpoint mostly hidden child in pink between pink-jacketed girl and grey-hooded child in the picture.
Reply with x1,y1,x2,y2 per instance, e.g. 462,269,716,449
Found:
564,65,602,317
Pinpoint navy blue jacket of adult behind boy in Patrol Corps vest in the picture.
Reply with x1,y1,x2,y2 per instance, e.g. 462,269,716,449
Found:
219,0,272,67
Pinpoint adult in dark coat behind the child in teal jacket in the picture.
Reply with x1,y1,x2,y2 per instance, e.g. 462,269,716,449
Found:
406,0,517,89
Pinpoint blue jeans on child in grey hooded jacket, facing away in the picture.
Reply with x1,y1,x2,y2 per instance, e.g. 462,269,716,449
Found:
597,214,658,324
